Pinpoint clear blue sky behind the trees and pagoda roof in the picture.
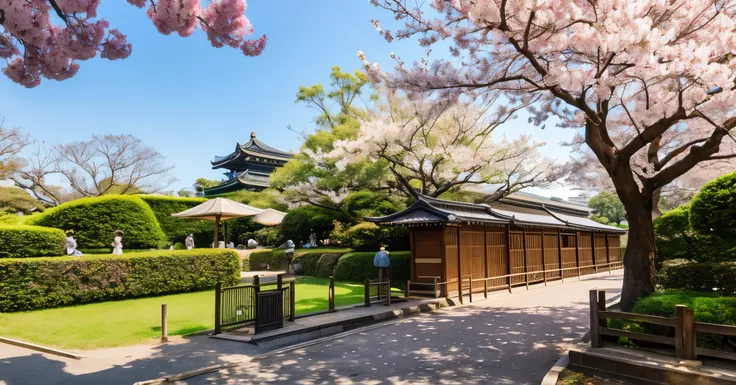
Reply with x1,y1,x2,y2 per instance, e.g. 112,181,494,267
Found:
0,0,577,196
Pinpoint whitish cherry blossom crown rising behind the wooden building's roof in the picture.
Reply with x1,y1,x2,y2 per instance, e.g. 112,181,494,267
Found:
322,92,556,201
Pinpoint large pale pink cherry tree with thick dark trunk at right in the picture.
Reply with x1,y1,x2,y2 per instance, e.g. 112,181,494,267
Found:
364,0,736,310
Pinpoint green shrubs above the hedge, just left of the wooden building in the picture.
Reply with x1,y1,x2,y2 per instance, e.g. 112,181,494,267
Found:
331,222,409,251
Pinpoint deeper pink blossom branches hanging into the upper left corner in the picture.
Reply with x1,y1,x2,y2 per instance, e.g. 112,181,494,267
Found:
0,0,266,88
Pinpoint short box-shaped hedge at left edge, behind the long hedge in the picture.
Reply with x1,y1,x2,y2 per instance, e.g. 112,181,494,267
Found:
0,226,66,258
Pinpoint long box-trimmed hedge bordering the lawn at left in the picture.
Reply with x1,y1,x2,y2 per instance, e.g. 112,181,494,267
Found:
0,249,240,312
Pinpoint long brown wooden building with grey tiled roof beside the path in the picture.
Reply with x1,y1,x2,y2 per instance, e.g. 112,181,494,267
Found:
366,195,626,296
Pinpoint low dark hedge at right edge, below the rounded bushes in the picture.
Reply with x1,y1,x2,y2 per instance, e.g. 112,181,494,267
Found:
655,262,736,296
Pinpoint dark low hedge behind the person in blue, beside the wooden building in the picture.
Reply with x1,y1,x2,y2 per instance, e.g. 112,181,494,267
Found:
334,251,411,283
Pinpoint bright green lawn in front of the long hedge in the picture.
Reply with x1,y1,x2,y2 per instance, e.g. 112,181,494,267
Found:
0,277,396,350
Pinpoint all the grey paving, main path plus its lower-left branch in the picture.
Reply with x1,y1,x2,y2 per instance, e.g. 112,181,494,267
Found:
0,272,622,385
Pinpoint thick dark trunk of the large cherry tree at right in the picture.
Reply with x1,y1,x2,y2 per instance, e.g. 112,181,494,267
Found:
621,201,656,311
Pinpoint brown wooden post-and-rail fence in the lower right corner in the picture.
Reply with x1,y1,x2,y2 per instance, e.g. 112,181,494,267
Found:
589,290,736,361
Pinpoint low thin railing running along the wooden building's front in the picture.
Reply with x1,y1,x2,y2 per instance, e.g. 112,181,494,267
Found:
406,261,623,304
